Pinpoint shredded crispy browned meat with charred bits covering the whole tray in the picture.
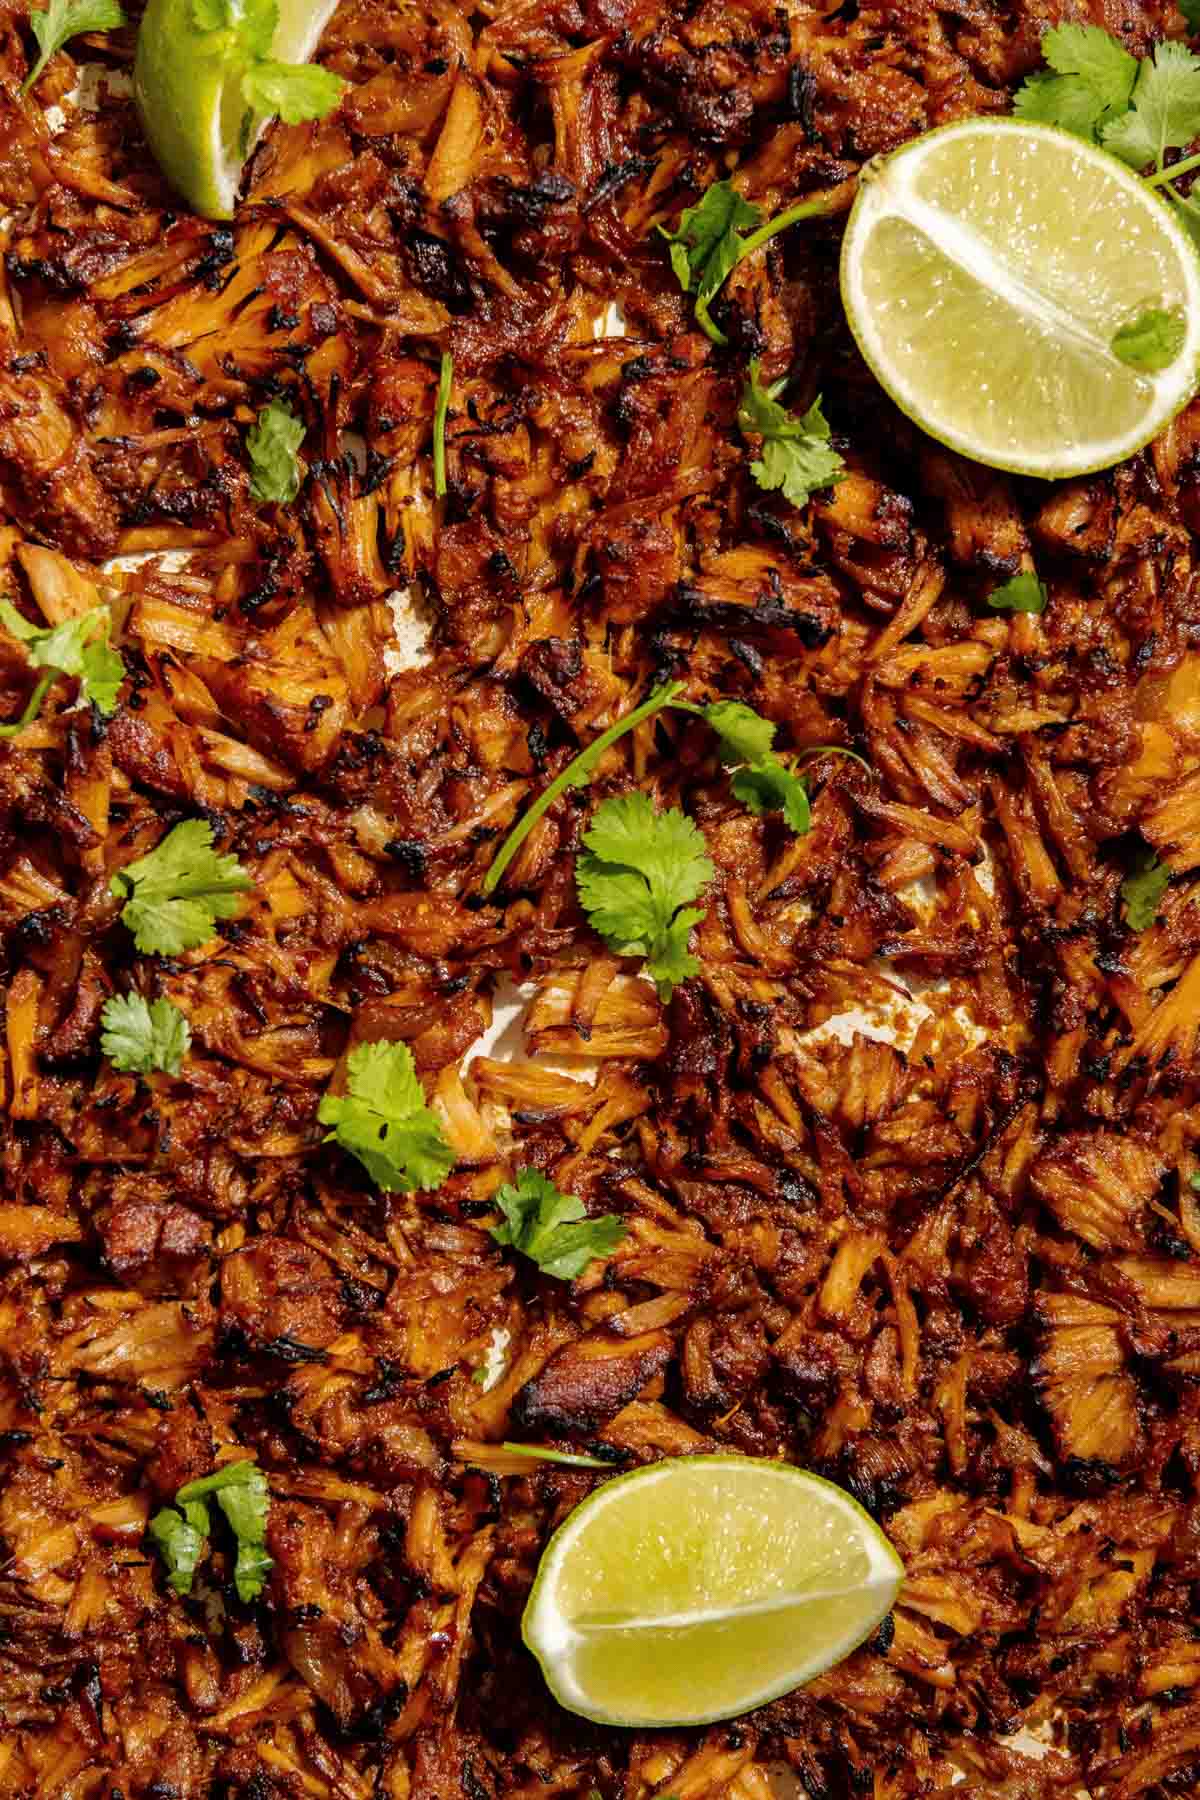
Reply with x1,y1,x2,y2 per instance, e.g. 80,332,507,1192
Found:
0,0,1200,1800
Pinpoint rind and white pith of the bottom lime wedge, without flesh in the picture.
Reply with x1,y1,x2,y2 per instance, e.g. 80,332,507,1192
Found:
522,1454,905,1728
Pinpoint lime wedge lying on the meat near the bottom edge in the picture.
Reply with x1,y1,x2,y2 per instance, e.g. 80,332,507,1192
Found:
522,1456,903,1726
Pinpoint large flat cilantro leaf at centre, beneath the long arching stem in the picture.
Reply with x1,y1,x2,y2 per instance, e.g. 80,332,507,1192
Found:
576,794,714,1001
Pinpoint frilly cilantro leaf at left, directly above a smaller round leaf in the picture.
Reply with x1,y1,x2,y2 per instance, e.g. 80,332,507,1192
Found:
110,819,254,956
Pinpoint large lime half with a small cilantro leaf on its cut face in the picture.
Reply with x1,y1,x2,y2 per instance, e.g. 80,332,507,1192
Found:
842,119,1200,477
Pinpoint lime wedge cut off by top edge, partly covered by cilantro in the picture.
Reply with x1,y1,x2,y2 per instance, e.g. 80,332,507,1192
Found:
133,0,338,220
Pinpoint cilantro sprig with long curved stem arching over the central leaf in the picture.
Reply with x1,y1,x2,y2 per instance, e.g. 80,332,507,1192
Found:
480,680,827,895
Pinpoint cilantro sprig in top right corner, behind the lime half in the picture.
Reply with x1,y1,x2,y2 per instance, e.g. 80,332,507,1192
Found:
1013,25,1200,270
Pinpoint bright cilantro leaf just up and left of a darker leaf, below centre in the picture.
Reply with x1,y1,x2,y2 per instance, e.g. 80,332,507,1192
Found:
317,1042,453,1193
